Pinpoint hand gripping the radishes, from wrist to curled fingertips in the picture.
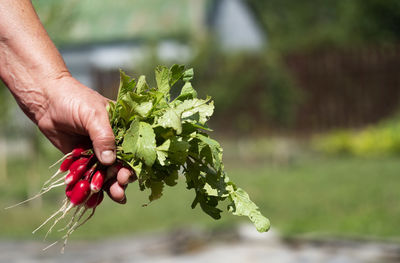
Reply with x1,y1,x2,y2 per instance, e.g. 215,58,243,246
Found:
36,75,136,204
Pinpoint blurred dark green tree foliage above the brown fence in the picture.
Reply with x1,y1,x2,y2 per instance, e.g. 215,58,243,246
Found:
247,0,400,50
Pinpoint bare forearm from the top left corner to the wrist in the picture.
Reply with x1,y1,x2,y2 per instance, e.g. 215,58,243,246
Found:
0,0,70,122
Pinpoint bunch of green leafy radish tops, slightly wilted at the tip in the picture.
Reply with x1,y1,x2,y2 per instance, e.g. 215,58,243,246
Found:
108,65,270,232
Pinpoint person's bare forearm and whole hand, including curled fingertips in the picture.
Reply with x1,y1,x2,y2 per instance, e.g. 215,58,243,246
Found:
0,0,135,204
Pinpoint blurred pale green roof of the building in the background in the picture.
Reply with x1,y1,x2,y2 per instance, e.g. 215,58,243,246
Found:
34,0,209,44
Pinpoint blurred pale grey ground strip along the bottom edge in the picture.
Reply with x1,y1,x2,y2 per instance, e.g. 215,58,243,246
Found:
0,225,400,263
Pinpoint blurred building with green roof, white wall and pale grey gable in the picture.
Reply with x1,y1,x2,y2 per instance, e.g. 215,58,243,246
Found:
46,0,266,96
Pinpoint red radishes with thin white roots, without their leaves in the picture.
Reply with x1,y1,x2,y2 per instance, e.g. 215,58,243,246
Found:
8,148,136,253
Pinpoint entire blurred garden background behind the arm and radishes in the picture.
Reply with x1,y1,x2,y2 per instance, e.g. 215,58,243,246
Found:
0,0,400,262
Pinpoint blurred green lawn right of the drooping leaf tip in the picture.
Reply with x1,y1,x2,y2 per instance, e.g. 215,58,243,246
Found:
231,157,400,239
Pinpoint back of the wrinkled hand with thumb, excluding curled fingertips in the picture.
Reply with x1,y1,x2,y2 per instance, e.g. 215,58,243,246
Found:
37,77,115,159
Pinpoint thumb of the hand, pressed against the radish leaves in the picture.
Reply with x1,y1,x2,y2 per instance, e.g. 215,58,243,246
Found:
87,112,116,165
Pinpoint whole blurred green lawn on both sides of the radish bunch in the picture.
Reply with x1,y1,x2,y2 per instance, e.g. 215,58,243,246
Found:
0,143,400,242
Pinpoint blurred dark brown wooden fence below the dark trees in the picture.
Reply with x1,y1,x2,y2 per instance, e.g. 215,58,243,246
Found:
286,46,400,130
